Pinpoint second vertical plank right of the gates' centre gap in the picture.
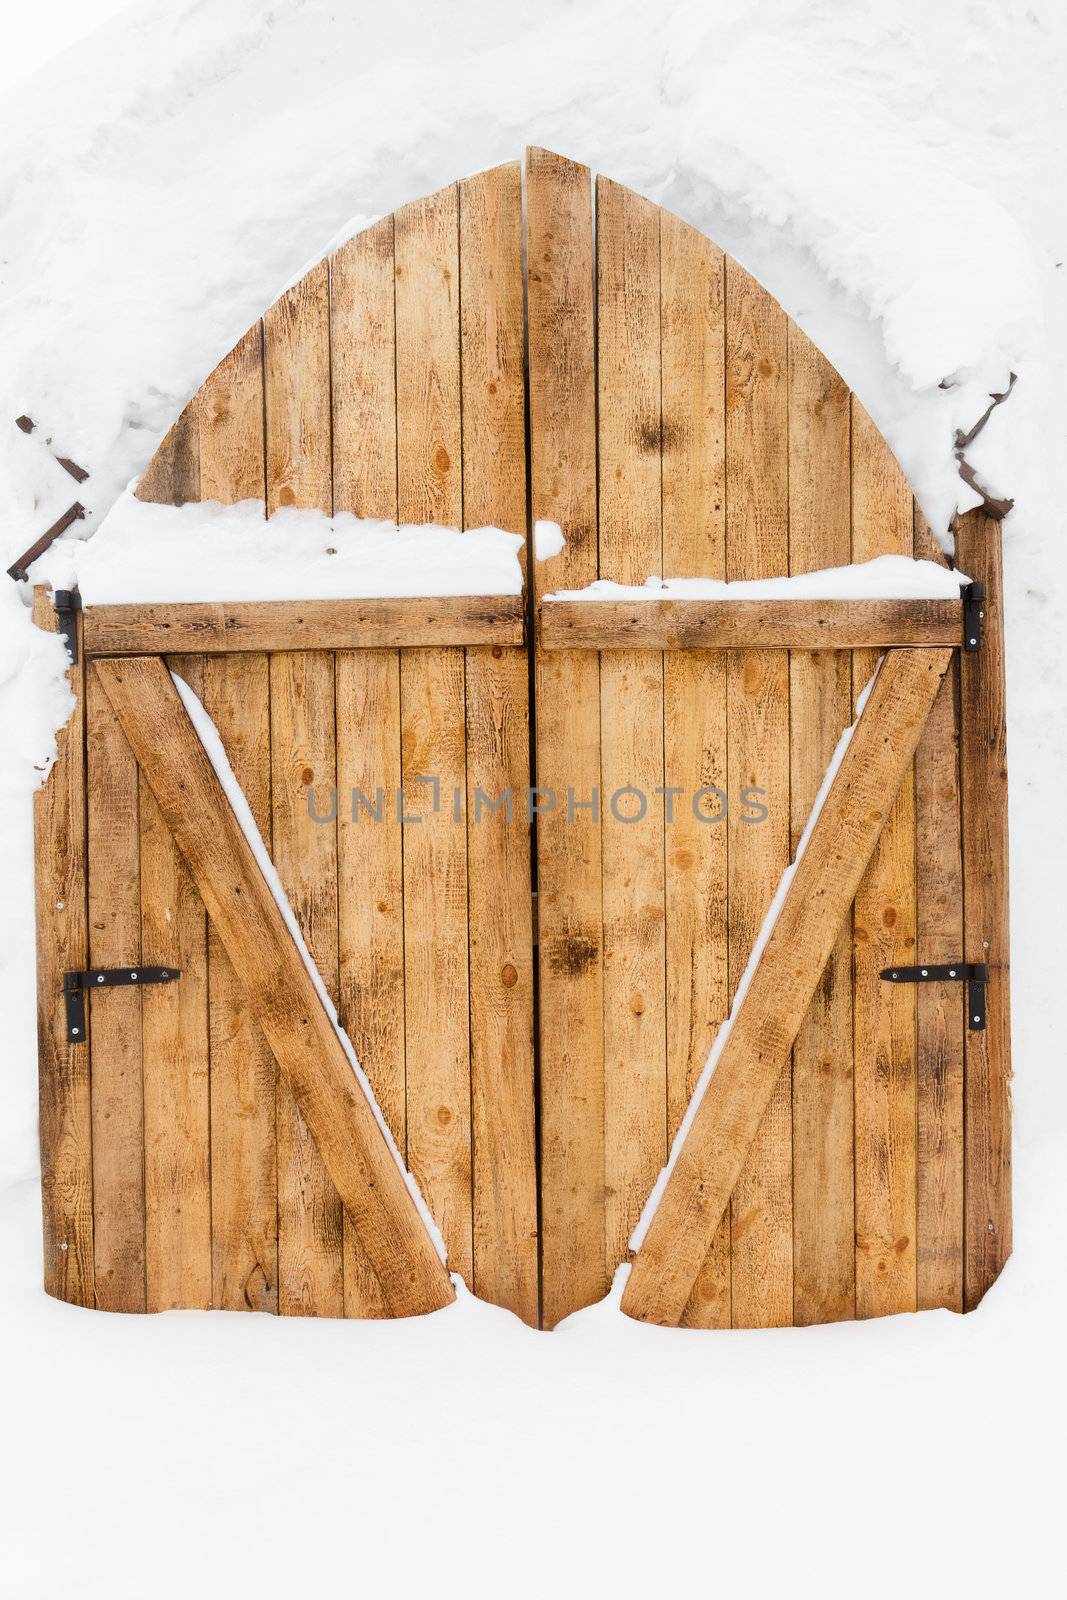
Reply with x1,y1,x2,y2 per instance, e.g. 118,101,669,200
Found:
597,178,667,1274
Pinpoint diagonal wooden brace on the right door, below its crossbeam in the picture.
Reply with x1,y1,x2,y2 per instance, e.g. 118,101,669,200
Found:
622,650,950,1323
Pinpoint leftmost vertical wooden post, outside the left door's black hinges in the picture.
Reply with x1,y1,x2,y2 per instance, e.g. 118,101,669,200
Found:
34,589,94,1306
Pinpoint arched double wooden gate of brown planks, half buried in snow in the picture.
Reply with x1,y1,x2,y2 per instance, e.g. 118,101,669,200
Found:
38,150,1009,1328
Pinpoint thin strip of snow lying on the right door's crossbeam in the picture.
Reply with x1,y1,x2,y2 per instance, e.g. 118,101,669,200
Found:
544,555,971,600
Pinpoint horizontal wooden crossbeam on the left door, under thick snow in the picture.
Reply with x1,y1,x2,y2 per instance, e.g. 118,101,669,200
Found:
85,595,525,656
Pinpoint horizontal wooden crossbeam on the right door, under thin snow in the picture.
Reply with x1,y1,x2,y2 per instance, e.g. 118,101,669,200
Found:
539,600,963,650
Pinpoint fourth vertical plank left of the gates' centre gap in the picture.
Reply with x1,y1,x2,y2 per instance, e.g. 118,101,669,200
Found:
264,261,337,1317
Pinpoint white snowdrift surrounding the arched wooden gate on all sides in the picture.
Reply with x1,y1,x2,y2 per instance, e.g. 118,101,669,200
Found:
0,0,1067,1600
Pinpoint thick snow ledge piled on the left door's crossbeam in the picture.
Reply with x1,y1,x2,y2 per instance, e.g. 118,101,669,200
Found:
30,485,525,605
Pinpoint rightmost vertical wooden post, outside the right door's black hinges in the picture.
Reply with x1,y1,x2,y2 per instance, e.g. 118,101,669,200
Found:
957,512,1011,1310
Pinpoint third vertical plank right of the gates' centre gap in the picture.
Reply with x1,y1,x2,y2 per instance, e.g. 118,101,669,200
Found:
659,211,729,1328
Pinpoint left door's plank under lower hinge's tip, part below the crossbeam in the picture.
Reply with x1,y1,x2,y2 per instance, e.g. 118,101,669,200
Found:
139,656,211,1310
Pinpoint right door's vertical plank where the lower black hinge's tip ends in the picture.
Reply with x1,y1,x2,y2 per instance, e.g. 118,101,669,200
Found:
851,395,917,1317
